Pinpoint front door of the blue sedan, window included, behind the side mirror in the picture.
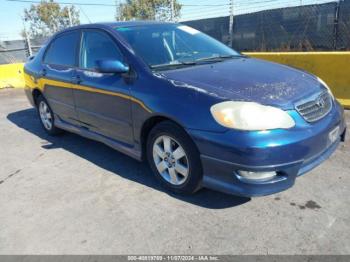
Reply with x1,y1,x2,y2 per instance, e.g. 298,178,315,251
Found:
73,29,133,145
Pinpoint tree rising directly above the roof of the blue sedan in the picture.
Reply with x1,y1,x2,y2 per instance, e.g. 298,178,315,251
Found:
116,0,181,21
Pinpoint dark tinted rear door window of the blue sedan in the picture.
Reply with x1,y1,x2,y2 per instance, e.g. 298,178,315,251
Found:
44,31,80,67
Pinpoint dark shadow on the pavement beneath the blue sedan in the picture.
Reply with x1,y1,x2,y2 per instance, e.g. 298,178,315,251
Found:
7,109,250,209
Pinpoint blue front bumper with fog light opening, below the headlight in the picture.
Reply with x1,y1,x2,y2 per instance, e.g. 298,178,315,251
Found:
189,102,346,197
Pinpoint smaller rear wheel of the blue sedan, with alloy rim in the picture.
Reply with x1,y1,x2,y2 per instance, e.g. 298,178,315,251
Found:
36,95,63,136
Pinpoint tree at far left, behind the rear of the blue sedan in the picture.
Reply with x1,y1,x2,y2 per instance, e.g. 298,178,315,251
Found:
24,0,80,37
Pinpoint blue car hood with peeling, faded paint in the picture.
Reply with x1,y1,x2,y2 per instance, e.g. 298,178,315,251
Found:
160,58,322,110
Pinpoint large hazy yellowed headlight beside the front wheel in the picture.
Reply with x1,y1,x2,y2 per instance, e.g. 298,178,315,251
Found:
210,101,295,131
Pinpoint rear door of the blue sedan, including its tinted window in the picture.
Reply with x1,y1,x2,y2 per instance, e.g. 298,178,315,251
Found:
40,30,80,123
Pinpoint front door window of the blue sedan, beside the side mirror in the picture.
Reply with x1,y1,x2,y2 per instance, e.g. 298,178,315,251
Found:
80,31,123,70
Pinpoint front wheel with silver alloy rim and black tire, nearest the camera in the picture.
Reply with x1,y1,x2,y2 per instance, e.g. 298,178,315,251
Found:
147,121,203,194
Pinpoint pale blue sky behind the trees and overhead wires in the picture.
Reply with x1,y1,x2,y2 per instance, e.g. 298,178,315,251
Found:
0,0,333,40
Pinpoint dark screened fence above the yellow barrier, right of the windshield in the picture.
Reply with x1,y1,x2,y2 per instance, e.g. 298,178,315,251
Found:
184,0,350,51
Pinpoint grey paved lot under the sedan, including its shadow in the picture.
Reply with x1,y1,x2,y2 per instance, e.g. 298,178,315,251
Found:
0,90,350,254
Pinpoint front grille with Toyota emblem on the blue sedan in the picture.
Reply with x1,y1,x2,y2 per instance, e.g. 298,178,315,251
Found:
296,91,332,122
